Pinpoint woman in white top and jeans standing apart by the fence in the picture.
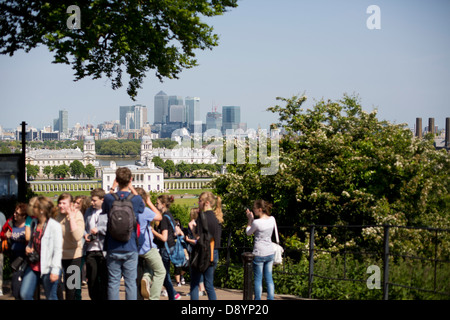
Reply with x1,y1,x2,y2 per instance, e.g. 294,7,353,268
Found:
246,200,275,300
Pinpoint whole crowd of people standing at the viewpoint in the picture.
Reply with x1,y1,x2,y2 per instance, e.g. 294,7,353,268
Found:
0,167,275,300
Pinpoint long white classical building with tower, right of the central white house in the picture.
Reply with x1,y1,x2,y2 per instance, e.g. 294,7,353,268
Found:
141,136,217,164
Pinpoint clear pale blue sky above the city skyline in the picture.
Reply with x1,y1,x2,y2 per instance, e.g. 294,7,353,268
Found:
0,0,450,129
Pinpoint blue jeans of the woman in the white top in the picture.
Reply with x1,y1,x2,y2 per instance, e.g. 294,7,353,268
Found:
253,254,275,300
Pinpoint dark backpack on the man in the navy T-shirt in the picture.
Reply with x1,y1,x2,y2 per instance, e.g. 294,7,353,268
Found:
107,193,137,242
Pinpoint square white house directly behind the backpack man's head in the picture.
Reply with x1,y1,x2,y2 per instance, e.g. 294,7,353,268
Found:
102,161,164,192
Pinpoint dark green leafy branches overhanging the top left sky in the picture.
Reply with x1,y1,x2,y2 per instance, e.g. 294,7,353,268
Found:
0,0,237,99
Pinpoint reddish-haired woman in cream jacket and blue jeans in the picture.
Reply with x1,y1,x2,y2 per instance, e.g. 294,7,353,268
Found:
20,196,63,300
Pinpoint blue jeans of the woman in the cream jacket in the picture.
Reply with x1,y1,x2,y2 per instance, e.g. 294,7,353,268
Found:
20,266,59,300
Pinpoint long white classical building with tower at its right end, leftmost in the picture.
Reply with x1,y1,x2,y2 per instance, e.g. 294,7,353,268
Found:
25,136,101,177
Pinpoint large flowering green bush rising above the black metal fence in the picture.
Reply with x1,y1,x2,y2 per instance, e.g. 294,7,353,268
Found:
213,95,450,236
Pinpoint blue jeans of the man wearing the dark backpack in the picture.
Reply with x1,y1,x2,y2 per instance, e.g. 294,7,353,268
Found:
106,251,138,300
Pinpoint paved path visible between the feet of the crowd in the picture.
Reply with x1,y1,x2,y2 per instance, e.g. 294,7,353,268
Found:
0,281,302,300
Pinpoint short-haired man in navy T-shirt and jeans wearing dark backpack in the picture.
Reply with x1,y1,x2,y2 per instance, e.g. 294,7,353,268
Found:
102,167,145,300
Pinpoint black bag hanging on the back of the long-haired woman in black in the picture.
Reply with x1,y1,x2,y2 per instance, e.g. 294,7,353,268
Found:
190,212,214,273
